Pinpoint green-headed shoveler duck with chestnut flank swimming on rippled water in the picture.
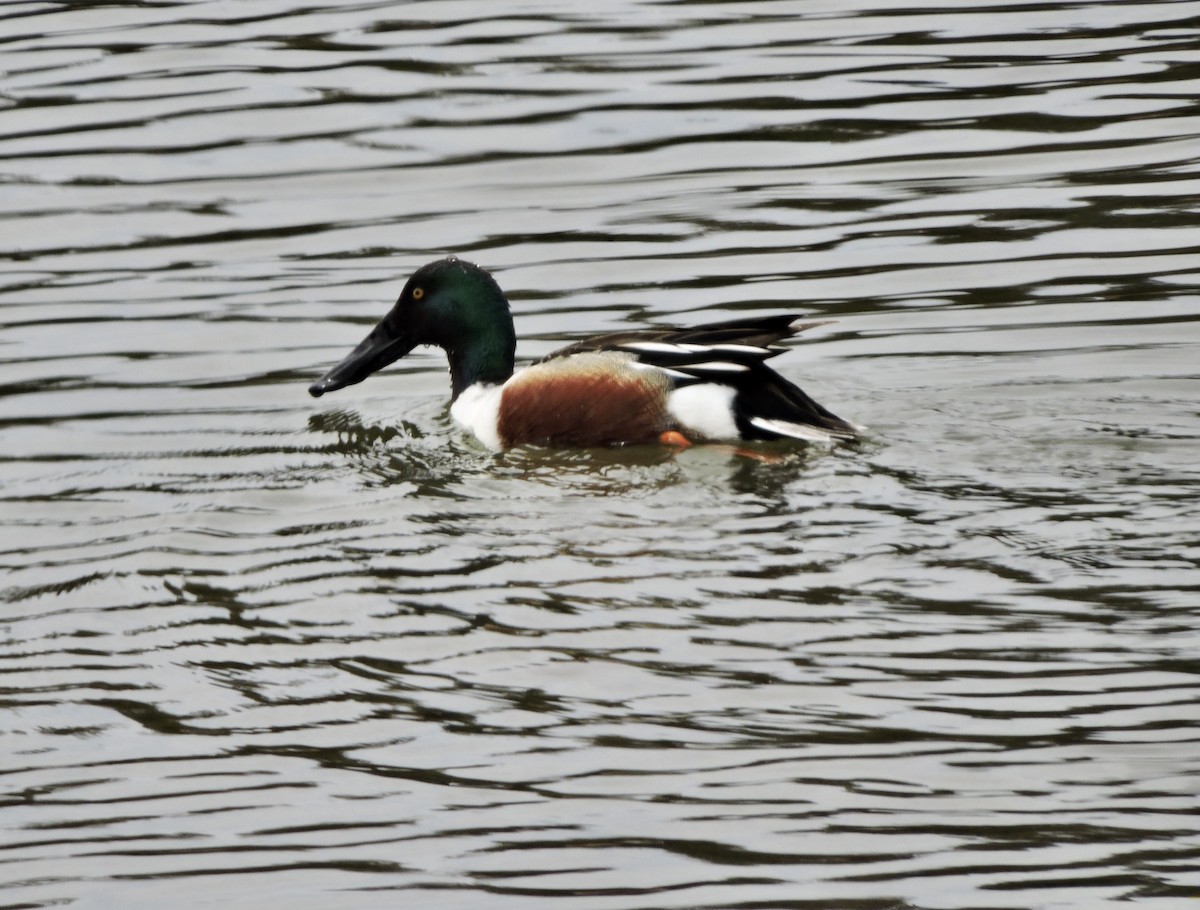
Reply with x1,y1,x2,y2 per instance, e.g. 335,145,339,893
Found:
308,256,862,451
